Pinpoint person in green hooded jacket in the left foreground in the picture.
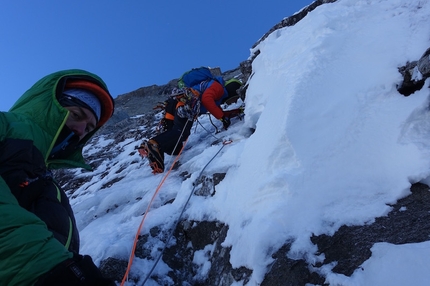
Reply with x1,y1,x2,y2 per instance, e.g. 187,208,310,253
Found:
0,70,115,285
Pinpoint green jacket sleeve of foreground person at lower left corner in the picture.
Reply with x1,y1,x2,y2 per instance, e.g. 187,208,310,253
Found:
0,177,73,285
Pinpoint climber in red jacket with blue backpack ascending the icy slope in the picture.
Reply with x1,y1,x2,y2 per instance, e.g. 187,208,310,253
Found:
138,68,243,174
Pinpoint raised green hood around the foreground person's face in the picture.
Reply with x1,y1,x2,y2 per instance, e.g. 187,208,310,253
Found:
5,69,113,170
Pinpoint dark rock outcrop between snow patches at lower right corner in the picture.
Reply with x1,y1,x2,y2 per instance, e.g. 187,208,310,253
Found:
311,183,430,276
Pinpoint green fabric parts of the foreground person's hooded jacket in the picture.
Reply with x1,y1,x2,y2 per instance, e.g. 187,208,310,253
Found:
0,70,113,285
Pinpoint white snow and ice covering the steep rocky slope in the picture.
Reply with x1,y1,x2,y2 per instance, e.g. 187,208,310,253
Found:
71,0,430,285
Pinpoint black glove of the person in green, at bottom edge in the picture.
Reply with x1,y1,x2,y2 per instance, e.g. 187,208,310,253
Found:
35,254,116,286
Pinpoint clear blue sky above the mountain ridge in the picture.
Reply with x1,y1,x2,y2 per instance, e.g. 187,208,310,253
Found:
0,0,313,111
